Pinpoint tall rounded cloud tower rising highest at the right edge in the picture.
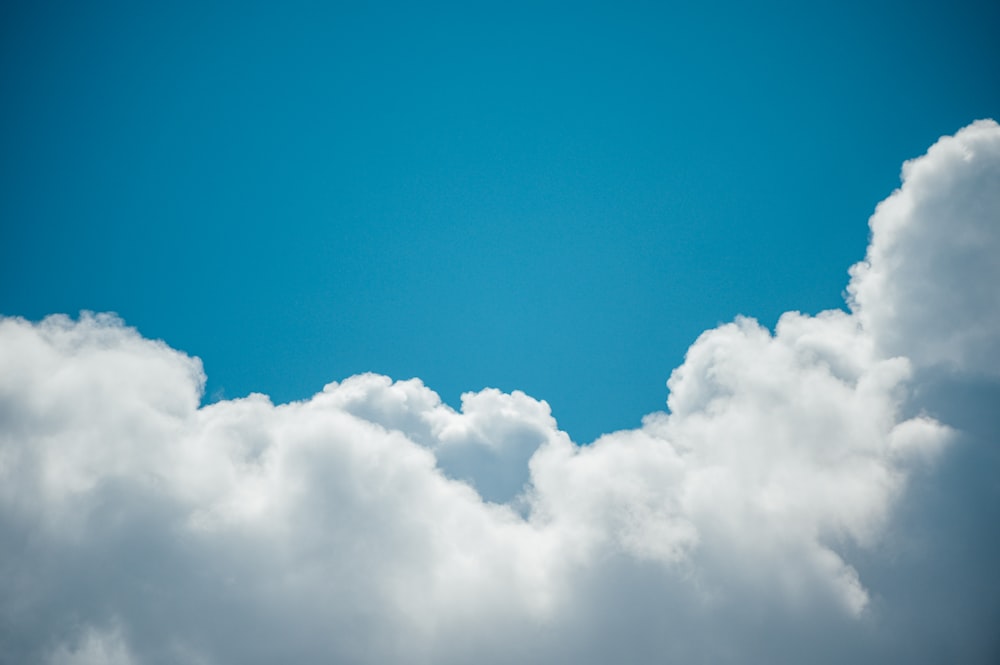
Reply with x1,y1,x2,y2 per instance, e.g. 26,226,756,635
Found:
848,120,1000,377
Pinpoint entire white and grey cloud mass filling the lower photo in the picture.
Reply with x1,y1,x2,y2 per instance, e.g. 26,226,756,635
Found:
0,121,1000,665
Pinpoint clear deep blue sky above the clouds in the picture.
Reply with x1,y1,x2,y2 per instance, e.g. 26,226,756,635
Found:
0,2,1000,442
